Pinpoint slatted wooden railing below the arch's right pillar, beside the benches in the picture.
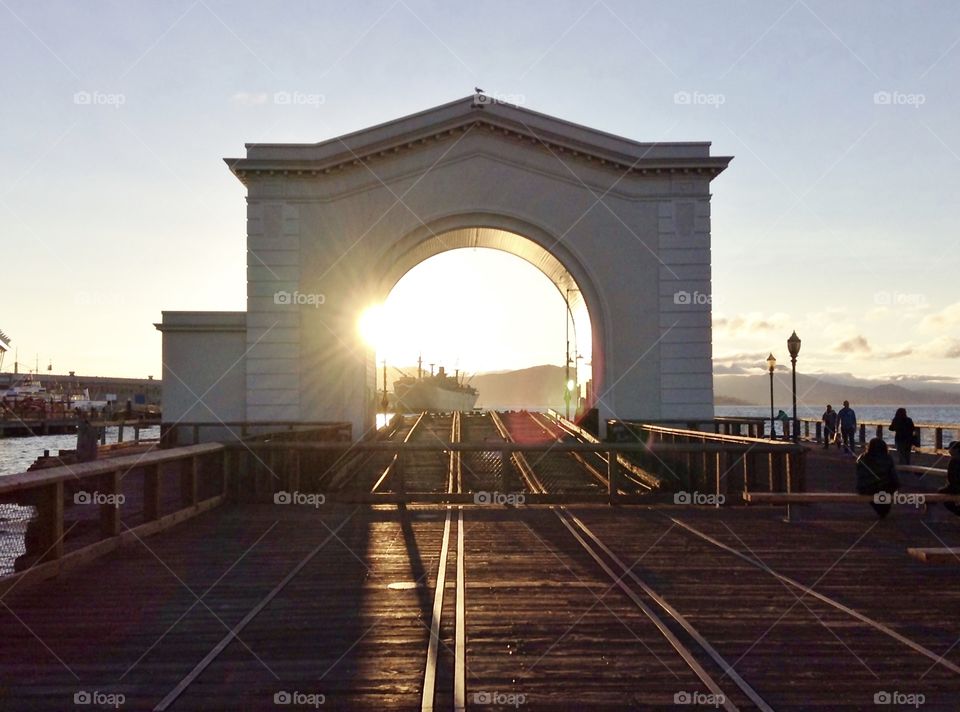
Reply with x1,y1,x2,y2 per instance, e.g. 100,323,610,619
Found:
607,420,806,503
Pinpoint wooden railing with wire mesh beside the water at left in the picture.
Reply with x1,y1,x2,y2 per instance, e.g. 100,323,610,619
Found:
0,443,228,593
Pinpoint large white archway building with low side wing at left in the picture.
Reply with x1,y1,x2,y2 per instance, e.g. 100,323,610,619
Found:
158,97,730,437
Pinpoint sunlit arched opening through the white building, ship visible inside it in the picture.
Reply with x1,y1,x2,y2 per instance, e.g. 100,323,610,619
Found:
361,226,602,416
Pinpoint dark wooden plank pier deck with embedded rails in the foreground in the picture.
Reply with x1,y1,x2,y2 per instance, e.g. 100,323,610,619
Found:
0,414,960,710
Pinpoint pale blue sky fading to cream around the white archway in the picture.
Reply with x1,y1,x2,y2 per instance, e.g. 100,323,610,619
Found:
0,0,960,376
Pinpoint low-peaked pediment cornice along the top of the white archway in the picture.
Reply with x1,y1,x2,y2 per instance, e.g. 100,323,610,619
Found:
224,95,731,182
